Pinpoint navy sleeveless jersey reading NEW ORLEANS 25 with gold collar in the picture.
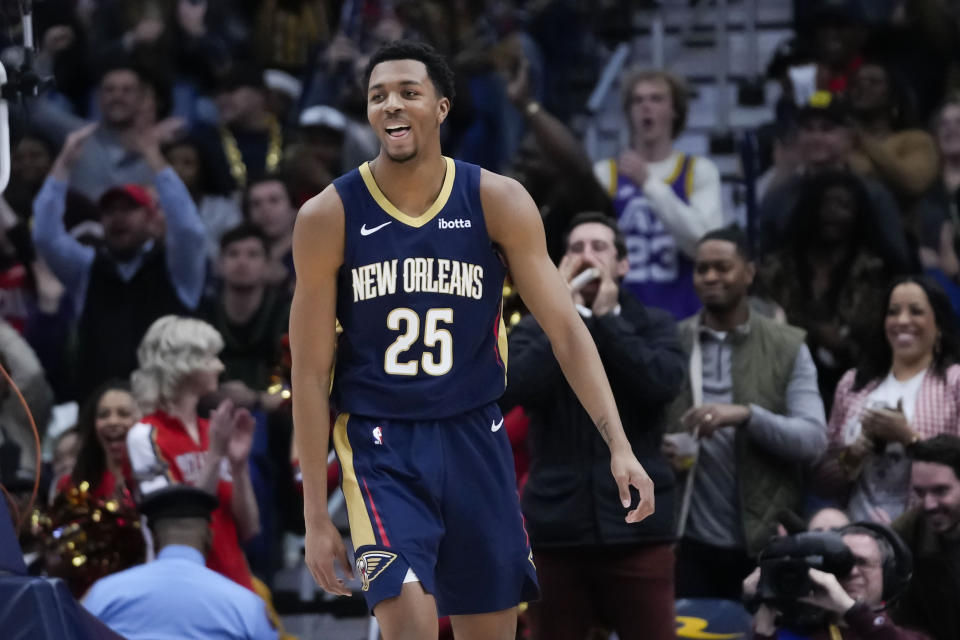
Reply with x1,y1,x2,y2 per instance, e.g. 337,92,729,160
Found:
333,158,507,420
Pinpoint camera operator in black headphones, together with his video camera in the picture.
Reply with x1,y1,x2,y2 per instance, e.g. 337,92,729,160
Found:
743,523,926,640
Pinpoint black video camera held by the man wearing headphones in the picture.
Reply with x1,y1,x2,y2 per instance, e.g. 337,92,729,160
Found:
749,531,855,633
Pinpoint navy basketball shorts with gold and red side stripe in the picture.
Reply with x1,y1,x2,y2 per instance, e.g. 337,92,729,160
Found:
333,403,539,616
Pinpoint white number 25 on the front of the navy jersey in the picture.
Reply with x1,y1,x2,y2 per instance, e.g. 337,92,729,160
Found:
383,307,453,376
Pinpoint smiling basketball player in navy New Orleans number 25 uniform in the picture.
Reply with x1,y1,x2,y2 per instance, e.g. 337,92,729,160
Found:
290,42,654,640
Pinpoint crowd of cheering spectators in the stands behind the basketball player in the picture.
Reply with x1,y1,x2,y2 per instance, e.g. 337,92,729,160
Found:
0,0,960,639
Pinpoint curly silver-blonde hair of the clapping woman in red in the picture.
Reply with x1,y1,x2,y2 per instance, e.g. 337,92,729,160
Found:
130,315,223,413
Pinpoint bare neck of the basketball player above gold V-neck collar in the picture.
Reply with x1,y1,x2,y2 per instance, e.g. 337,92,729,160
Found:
370,146,447,217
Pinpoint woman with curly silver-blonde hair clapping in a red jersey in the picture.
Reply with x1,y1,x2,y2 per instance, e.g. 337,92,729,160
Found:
127,316,260,590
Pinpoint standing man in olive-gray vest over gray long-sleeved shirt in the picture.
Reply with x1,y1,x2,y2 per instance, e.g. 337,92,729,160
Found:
664,226,827,600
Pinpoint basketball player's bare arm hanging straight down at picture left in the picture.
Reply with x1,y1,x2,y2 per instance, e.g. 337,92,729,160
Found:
290,185,352,595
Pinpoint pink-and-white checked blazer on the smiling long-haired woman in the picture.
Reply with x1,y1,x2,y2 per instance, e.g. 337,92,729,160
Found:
827,364,960,446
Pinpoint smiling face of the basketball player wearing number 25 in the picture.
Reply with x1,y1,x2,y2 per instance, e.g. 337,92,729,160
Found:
367,60,450,162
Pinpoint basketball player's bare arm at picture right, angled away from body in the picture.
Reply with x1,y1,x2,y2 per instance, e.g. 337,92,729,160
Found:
480,171,654,522
